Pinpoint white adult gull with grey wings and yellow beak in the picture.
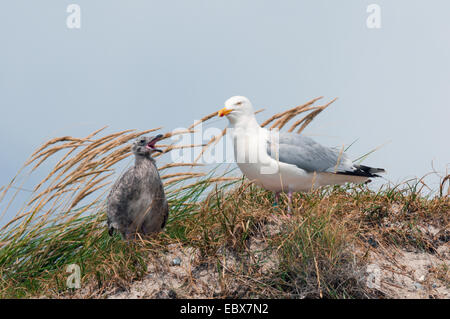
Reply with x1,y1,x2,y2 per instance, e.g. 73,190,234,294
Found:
218,96,384,205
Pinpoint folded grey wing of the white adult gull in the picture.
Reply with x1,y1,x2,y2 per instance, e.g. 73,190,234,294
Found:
267,132,355,172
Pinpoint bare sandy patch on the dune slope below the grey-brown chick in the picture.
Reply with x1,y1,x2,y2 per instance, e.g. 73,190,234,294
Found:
107,238,277,299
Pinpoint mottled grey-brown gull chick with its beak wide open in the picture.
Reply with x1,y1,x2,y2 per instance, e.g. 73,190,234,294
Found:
106,134,169,239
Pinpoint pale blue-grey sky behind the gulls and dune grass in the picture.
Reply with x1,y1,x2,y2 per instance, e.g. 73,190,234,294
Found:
0,0,450,218
